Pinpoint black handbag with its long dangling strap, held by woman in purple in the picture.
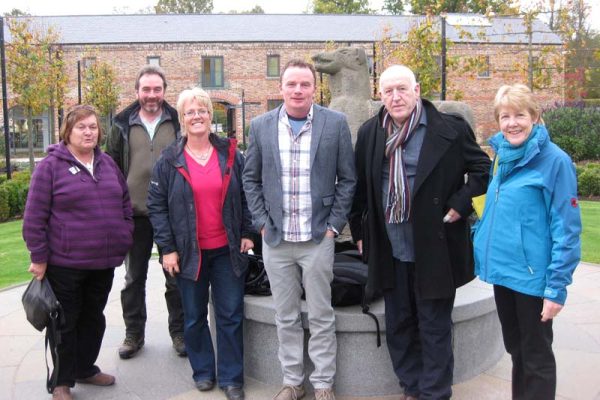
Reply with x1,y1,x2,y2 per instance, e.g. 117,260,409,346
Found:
21,277,65,393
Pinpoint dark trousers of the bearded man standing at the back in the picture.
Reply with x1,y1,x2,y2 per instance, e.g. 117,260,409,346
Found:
121,217,183,338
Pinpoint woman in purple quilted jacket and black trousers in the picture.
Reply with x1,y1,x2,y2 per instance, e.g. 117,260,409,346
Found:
23,105,133,400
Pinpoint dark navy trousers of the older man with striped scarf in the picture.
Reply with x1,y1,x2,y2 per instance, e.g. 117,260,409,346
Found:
383,260,454,400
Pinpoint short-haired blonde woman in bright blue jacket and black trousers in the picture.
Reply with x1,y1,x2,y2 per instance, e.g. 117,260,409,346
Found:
474,84,581,399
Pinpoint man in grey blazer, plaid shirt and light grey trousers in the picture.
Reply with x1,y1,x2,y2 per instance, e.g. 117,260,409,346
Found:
243,60,356,400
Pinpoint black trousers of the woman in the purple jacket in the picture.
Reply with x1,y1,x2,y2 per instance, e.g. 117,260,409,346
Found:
46,265,115,387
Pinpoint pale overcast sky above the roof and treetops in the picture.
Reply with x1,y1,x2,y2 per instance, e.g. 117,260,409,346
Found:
0,0,600,31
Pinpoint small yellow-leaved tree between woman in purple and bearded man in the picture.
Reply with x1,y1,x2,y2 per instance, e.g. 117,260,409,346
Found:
84,62,119,139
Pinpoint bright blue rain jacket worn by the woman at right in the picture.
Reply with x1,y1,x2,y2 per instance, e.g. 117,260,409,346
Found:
473,125,581,304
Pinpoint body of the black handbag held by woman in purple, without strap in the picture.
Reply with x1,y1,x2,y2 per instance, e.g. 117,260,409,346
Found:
21,277,60,332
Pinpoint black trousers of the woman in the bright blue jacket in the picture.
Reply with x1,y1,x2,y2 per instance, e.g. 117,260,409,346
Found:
494,285,556,400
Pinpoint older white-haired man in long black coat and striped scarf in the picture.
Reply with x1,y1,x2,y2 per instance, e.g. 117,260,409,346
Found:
350,65,490,399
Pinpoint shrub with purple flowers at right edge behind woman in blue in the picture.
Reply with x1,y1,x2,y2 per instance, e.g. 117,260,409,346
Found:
543,107,600,162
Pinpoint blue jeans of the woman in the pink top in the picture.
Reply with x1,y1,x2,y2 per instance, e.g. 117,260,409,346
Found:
177,246,244,387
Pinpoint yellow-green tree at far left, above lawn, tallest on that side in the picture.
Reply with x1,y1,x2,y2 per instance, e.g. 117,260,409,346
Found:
6,18,65,171
